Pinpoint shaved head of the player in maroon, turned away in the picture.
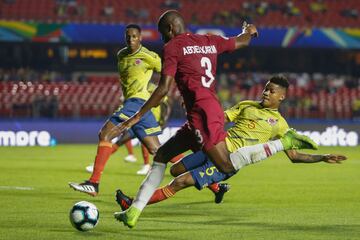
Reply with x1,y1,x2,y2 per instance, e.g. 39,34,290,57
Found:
158,10,186,43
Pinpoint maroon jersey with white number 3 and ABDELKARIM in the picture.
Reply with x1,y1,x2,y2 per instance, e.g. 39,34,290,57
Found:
162,33,235,112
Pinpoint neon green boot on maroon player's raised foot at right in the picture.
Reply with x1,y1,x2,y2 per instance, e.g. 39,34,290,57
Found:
280,128,318,150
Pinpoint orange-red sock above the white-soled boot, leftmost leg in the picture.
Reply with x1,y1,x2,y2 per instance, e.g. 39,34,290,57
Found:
89,141,113,183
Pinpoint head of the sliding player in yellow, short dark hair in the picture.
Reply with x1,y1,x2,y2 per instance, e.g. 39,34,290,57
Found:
261,75,289,109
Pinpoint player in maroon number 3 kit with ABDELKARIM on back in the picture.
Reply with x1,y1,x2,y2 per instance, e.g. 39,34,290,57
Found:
113,10,258,228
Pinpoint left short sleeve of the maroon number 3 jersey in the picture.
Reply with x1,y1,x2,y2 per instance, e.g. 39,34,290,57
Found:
162,44,178,77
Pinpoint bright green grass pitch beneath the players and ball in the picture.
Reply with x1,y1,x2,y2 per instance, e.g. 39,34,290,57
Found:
0,145,360,240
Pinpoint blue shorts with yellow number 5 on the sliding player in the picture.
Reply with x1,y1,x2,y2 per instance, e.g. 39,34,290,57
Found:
181,151,235,190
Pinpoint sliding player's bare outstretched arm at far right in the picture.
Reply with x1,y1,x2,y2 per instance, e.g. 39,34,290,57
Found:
285,150,347,163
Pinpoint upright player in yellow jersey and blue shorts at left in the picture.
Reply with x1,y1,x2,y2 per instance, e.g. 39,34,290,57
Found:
69,24,161,196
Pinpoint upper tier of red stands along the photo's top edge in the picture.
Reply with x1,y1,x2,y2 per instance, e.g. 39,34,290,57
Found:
0,0,360,27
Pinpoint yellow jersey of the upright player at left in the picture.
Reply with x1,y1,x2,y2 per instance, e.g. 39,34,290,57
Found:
117,46,161,100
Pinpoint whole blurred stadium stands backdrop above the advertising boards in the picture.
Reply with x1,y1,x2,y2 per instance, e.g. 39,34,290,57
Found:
0,0,360,122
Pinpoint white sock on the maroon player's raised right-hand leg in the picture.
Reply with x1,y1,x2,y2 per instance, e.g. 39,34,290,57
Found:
230,140,284,170
